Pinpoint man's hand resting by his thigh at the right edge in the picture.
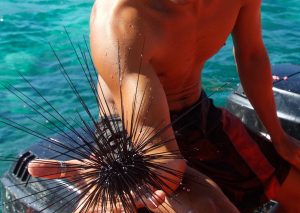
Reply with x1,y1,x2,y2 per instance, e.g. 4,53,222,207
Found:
272,133,300,170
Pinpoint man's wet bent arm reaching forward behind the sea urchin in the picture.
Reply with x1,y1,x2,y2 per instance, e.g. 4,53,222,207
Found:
91,3,186,191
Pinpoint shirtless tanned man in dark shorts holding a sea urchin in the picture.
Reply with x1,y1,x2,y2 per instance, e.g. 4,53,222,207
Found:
30,0,300,213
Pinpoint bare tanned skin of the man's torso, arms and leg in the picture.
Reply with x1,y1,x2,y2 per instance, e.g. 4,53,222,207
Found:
30,0,300,213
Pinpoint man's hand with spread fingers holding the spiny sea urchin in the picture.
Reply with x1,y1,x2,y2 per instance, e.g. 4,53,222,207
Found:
28,159,166,213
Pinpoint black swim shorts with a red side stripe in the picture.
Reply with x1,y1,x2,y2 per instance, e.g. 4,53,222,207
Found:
170,91,290,212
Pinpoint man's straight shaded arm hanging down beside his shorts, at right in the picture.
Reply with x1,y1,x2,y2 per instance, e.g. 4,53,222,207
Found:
232,0,300,168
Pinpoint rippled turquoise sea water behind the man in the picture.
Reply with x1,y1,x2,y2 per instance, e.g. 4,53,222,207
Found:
0,0,300,209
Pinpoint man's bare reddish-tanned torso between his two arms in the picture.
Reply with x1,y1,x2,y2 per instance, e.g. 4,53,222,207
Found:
91,0,244,110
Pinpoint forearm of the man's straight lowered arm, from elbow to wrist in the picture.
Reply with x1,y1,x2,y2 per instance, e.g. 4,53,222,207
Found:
238,49,284,142
